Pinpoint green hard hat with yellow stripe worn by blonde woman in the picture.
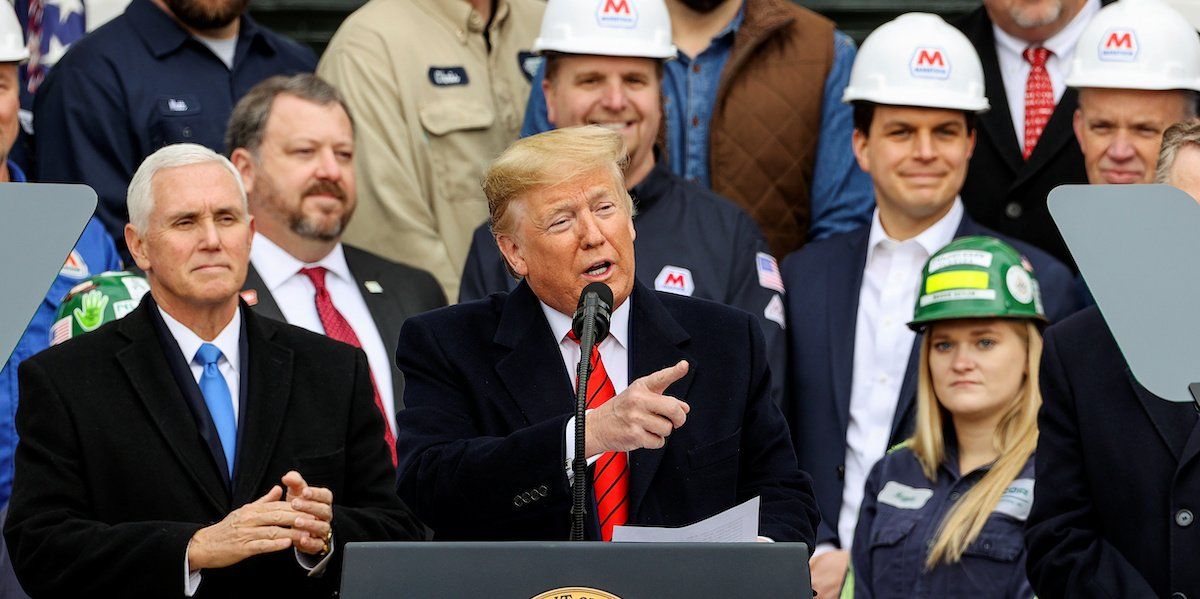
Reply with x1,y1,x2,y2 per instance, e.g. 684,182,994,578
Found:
908,236,1046,331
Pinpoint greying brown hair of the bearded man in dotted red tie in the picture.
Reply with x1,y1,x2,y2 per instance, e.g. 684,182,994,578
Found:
224,73,354,156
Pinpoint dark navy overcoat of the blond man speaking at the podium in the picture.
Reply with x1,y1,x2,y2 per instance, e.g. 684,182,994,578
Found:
396,283,817,544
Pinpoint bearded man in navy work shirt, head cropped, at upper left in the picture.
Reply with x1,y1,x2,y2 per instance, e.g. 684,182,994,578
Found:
34,0,317,256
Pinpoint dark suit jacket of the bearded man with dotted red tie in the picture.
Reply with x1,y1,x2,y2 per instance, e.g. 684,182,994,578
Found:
242,244,446,412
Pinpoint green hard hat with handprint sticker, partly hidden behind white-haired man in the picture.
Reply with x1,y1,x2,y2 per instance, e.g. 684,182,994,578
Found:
50,270,150,346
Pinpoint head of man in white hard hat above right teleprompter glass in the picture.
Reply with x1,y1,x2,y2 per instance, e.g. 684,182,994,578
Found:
1067,0,1200,185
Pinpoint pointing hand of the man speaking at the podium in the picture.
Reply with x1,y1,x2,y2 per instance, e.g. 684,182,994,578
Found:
584,360,691,457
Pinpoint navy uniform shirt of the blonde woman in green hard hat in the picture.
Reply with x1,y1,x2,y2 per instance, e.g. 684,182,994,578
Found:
846,445,1033,599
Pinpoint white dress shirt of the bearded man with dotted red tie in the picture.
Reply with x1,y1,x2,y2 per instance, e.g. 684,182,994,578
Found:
250,233,396,436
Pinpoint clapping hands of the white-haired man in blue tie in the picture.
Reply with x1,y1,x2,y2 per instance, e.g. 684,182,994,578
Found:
187,471,334,570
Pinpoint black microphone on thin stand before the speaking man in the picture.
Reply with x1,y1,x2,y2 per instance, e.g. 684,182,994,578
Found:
571,282,612,540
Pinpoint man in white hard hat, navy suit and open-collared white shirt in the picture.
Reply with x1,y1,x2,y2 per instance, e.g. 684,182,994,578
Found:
782,13,1079,597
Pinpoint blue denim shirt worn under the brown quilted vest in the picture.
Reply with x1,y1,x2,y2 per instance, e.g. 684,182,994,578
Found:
521,4,875,239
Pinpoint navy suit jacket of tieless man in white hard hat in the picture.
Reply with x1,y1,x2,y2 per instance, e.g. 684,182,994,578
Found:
782,215,1080,543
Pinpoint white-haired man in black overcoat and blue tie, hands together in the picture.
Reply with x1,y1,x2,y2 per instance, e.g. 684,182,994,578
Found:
5,144,424,598
